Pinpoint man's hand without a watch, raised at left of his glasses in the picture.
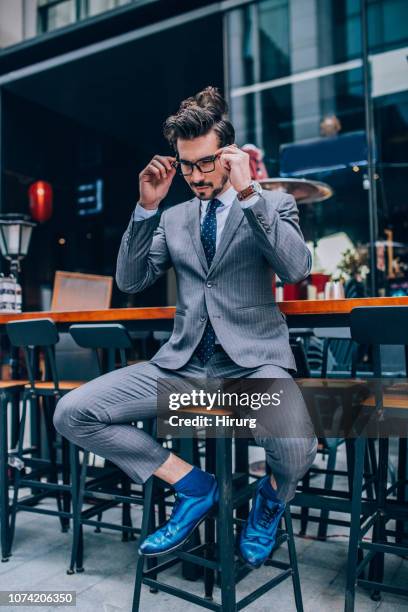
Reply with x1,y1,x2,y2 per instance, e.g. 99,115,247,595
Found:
139,155,176,210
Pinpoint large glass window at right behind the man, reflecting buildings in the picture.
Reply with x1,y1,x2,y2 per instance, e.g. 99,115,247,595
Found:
226,0,408,295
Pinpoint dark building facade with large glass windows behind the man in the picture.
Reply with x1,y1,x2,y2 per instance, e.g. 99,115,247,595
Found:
0,0,408,308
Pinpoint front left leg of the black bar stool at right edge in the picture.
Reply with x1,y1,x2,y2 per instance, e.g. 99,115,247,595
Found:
344,438,366,612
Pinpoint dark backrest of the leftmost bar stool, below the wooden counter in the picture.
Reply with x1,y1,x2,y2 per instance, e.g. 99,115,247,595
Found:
6,318,59,390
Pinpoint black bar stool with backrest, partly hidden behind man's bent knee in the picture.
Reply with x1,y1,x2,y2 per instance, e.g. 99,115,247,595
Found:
67,323,170,574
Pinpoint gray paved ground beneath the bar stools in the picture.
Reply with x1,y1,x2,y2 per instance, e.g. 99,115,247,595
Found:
0,444,408,612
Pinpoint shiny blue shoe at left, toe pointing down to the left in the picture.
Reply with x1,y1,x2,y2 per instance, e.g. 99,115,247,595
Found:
139,476,219,557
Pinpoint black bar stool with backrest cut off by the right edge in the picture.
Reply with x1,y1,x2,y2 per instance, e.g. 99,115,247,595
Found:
346,306,408,612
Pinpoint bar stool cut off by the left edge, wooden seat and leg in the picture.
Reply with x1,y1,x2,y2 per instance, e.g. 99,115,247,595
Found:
0,380,27,563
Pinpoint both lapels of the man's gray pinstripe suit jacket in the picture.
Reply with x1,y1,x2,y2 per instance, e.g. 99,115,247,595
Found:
187,198,244,273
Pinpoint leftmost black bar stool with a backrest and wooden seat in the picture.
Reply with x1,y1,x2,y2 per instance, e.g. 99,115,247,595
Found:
6,318,81,551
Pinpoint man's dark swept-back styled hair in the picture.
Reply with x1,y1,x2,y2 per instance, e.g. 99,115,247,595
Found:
163,86,235,152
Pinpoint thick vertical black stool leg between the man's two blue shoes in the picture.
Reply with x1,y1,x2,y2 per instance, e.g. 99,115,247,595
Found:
216,432,237,612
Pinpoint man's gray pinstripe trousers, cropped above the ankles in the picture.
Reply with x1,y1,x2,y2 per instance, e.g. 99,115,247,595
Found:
54,351,317,501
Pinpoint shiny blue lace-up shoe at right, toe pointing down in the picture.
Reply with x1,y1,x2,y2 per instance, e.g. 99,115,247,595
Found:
239,476,286,568
